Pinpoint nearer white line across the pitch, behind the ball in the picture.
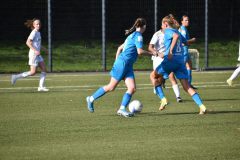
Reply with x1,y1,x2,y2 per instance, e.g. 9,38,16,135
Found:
0,82,240,91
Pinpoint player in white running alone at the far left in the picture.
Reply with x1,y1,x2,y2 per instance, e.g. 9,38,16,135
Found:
11,18,49,92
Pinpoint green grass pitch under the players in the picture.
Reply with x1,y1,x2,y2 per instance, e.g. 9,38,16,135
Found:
0,71,240,160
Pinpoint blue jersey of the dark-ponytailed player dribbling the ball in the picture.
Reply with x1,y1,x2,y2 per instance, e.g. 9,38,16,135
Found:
118,31,143,64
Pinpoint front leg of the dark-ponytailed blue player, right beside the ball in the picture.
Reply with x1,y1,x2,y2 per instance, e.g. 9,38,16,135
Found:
117,77,136,117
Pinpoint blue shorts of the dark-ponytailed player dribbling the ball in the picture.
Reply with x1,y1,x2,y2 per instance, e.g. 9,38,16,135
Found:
110,58,135,81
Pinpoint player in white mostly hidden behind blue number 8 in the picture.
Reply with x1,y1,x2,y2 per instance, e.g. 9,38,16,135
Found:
148,30,182,102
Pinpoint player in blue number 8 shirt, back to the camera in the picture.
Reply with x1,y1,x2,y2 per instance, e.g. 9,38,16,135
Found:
152,15,206,114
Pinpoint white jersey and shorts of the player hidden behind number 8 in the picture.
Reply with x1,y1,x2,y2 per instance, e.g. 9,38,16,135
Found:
150,30,165,70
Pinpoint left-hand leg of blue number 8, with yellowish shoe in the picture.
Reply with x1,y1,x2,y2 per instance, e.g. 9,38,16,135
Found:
150,71,168,110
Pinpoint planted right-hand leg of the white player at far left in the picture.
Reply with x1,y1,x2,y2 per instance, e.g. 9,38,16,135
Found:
38,60,49,92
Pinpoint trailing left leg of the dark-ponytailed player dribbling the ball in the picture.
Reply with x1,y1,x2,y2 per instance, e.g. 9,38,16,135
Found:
86,77,119,112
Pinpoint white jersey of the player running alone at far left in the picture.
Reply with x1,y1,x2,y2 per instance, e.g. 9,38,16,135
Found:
28,29,41,53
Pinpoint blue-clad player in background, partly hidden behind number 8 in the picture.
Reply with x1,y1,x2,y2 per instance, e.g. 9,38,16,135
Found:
179,15,197,89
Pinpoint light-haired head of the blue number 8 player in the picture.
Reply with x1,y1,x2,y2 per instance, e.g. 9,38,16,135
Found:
162,14,180,29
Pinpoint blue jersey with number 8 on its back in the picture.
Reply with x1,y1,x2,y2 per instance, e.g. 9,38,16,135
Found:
164,28,186,63
